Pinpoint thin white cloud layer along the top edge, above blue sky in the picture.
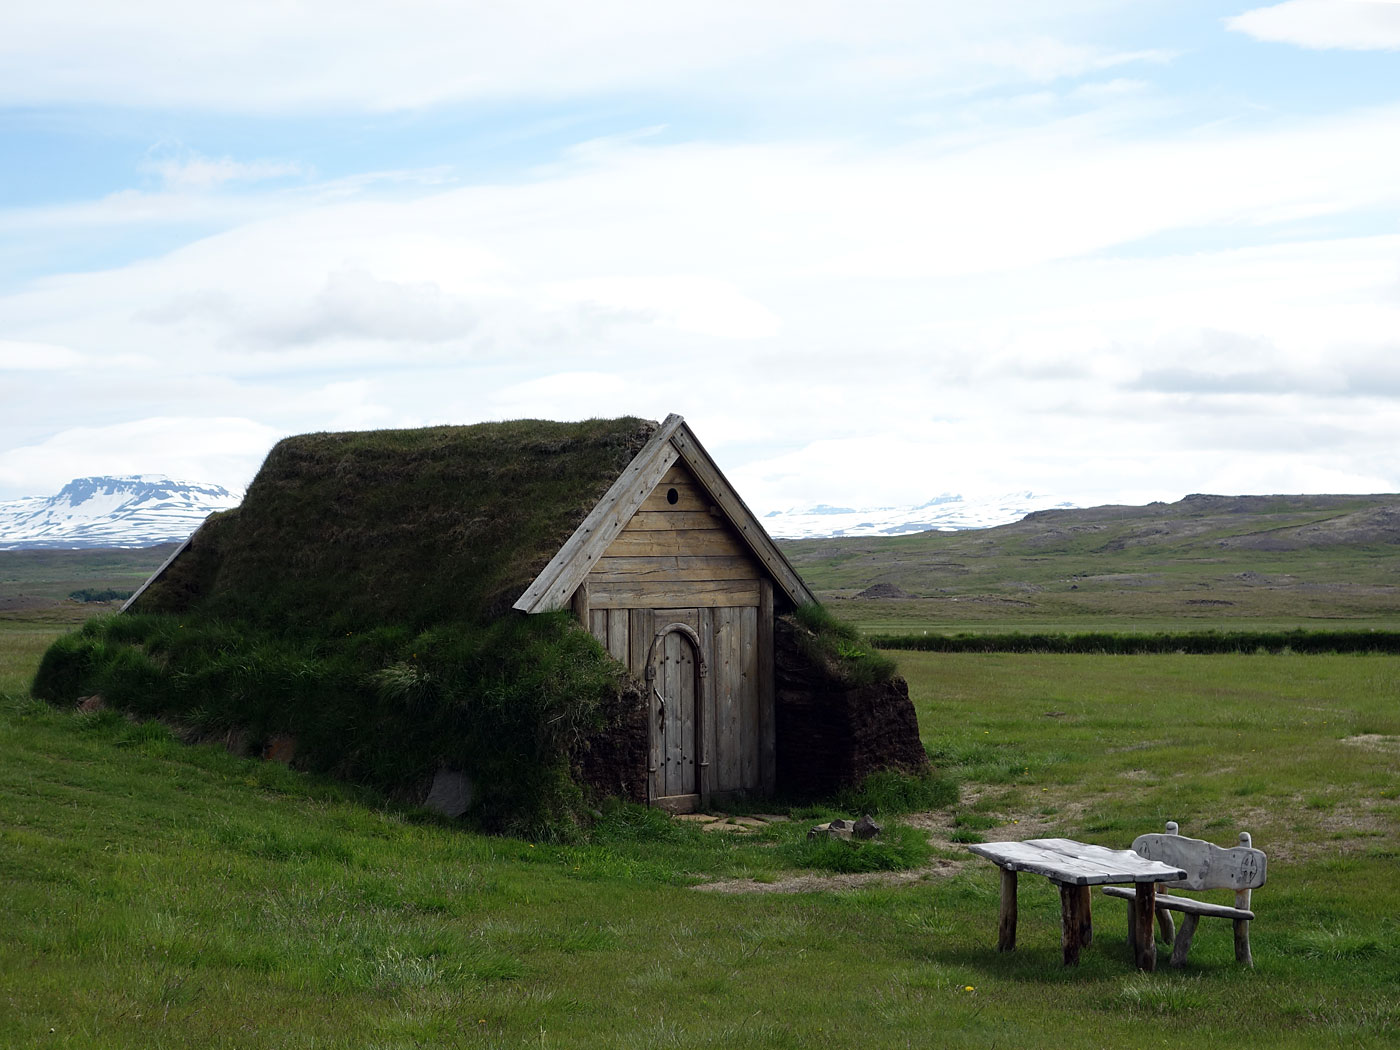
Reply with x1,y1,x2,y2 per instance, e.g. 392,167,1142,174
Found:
0,0,1156,112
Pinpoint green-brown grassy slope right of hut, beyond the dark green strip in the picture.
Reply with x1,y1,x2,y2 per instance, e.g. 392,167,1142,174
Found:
783,496,1400,630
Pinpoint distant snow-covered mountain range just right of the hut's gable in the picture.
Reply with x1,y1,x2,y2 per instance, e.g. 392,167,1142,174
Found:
763,493,1077,539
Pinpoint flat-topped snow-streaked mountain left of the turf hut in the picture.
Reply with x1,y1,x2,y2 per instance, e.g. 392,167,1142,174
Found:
0,475,241,550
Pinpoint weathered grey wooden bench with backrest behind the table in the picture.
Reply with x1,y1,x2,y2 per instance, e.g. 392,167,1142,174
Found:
1103,820,1268,967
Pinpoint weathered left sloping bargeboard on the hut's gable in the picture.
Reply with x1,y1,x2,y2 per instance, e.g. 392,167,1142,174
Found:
512,413,685,613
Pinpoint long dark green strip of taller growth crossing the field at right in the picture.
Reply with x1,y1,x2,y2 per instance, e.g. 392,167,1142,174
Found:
868,630,1400,655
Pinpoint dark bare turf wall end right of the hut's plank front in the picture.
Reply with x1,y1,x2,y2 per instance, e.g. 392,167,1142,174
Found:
773,616,928,798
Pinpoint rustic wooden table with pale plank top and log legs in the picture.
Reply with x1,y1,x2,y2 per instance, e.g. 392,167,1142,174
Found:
967,839,1186,970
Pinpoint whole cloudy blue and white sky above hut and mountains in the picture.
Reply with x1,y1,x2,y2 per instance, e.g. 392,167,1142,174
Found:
0,0,1400,514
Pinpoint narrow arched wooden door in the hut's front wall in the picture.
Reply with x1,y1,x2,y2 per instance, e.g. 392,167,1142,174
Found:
648,624,700,798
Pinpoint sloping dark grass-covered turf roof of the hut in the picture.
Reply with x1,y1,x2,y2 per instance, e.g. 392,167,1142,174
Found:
133,417,657,629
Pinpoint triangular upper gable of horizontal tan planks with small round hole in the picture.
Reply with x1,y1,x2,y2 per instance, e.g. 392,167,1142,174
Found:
587,462,763,609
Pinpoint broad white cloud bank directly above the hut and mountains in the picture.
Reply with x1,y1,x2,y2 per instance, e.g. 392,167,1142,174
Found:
0,67,1400,508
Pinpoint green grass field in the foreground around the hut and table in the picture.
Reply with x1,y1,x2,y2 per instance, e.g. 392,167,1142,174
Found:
0,620,1400,1047
